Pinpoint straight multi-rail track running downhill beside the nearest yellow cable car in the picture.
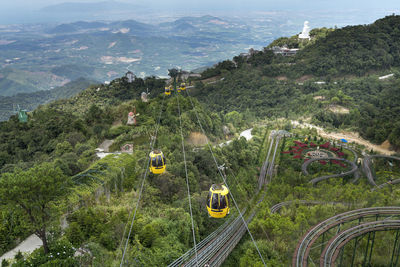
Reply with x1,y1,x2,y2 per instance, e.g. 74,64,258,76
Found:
168,131,286,267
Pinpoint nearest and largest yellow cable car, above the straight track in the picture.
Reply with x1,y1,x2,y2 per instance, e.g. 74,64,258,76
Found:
207,184,230,218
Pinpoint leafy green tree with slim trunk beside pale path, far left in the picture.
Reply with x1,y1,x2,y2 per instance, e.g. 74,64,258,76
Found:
0,163,68,254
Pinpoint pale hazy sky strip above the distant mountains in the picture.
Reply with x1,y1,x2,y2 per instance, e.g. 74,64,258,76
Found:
0,0,400,24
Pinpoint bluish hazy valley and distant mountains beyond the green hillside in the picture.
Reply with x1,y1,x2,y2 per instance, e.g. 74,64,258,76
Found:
0,15,276,96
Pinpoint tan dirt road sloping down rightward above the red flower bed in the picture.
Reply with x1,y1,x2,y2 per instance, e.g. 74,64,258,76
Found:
291,121,396,155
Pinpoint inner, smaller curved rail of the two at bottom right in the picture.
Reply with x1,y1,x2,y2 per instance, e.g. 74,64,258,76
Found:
320,220,400,267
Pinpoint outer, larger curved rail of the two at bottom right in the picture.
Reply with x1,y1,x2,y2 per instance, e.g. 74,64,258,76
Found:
292,207,400,267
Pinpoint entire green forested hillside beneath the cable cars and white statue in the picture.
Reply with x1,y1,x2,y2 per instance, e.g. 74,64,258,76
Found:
0,16,400,267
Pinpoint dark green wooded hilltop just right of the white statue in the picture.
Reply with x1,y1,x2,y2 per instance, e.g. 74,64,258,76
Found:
296,15,400,76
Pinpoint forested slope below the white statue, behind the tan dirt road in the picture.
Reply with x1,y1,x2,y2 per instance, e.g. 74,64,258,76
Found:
195,16,400,147
